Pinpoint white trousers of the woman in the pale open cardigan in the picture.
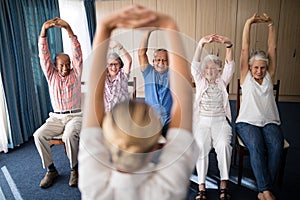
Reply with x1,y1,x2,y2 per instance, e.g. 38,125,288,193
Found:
193,116,232,184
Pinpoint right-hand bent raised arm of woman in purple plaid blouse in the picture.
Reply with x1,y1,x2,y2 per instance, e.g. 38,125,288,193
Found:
109,40,132,74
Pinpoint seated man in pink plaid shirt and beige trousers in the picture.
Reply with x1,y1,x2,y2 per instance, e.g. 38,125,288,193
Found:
34,18,82,188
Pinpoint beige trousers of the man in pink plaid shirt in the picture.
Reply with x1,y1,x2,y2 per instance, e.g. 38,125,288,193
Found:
33,112,82,168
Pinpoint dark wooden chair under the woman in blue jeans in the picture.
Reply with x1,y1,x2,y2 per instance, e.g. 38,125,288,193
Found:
233,79,290,186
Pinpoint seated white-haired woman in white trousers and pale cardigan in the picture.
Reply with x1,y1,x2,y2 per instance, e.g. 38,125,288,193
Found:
192,34,235,200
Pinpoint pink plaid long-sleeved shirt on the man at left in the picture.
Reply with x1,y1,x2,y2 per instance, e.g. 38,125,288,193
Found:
38,36,82,112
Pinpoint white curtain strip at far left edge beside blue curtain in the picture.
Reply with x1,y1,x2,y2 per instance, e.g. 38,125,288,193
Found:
0,73,11,153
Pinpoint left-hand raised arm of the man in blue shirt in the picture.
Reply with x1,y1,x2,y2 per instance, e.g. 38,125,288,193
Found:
138,30,151,72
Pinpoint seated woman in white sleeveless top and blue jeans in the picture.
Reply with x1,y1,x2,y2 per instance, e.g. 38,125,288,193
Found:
236,14,284,200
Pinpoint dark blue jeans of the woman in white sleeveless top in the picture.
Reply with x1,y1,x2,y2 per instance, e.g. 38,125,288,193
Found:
236,122,284,192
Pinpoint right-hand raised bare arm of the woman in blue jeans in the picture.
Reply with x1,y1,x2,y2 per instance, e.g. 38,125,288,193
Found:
264,13,277,82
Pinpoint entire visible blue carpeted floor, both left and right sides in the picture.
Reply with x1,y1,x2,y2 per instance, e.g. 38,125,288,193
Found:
0,102,300,200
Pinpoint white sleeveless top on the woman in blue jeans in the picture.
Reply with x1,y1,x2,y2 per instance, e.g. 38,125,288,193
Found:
236,71,281,127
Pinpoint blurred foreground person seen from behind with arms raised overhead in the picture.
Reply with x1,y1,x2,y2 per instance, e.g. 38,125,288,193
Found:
78,5,197,199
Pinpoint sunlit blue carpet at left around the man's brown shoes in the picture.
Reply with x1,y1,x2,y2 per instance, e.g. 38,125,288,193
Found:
0,139,81,200
